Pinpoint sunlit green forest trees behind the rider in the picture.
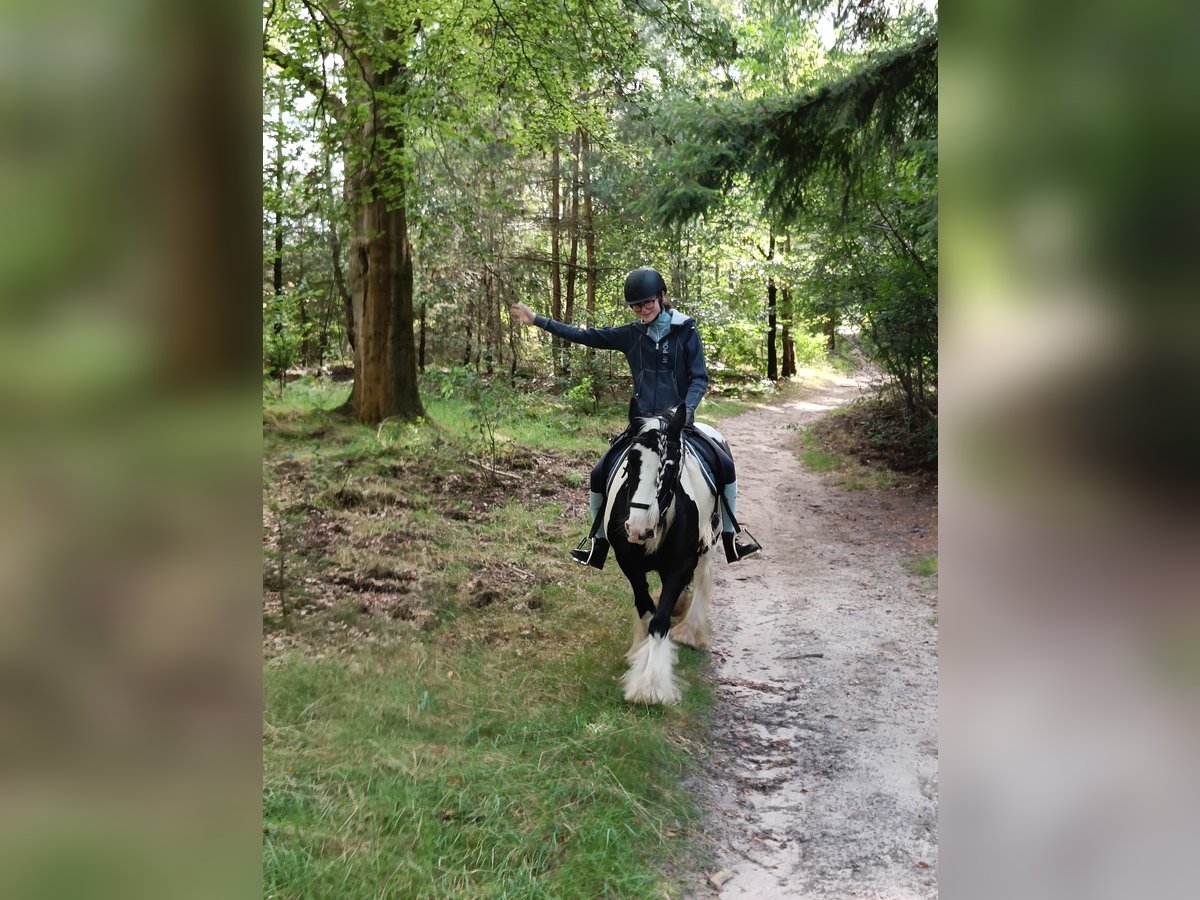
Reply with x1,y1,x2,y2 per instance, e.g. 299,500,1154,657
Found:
263,0,937,444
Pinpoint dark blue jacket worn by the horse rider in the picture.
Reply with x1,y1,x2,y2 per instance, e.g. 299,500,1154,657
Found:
533,310,708,415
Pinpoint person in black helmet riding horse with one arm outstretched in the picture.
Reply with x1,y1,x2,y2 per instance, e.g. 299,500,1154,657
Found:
509,268,762,569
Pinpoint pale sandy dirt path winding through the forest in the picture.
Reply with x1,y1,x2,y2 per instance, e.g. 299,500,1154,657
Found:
688,379,937,900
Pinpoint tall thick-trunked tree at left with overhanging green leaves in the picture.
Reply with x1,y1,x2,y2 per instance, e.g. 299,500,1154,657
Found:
263,0,641,421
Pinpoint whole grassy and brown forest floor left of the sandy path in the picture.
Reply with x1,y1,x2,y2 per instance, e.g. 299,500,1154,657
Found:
263,382,713,898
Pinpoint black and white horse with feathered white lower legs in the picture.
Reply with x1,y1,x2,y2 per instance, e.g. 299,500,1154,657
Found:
604,404,721,703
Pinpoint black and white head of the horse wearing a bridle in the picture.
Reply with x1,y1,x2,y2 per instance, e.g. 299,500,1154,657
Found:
625,403,688,544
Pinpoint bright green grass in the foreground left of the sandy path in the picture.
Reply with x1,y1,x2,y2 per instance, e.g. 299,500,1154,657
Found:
264,638,703,898
